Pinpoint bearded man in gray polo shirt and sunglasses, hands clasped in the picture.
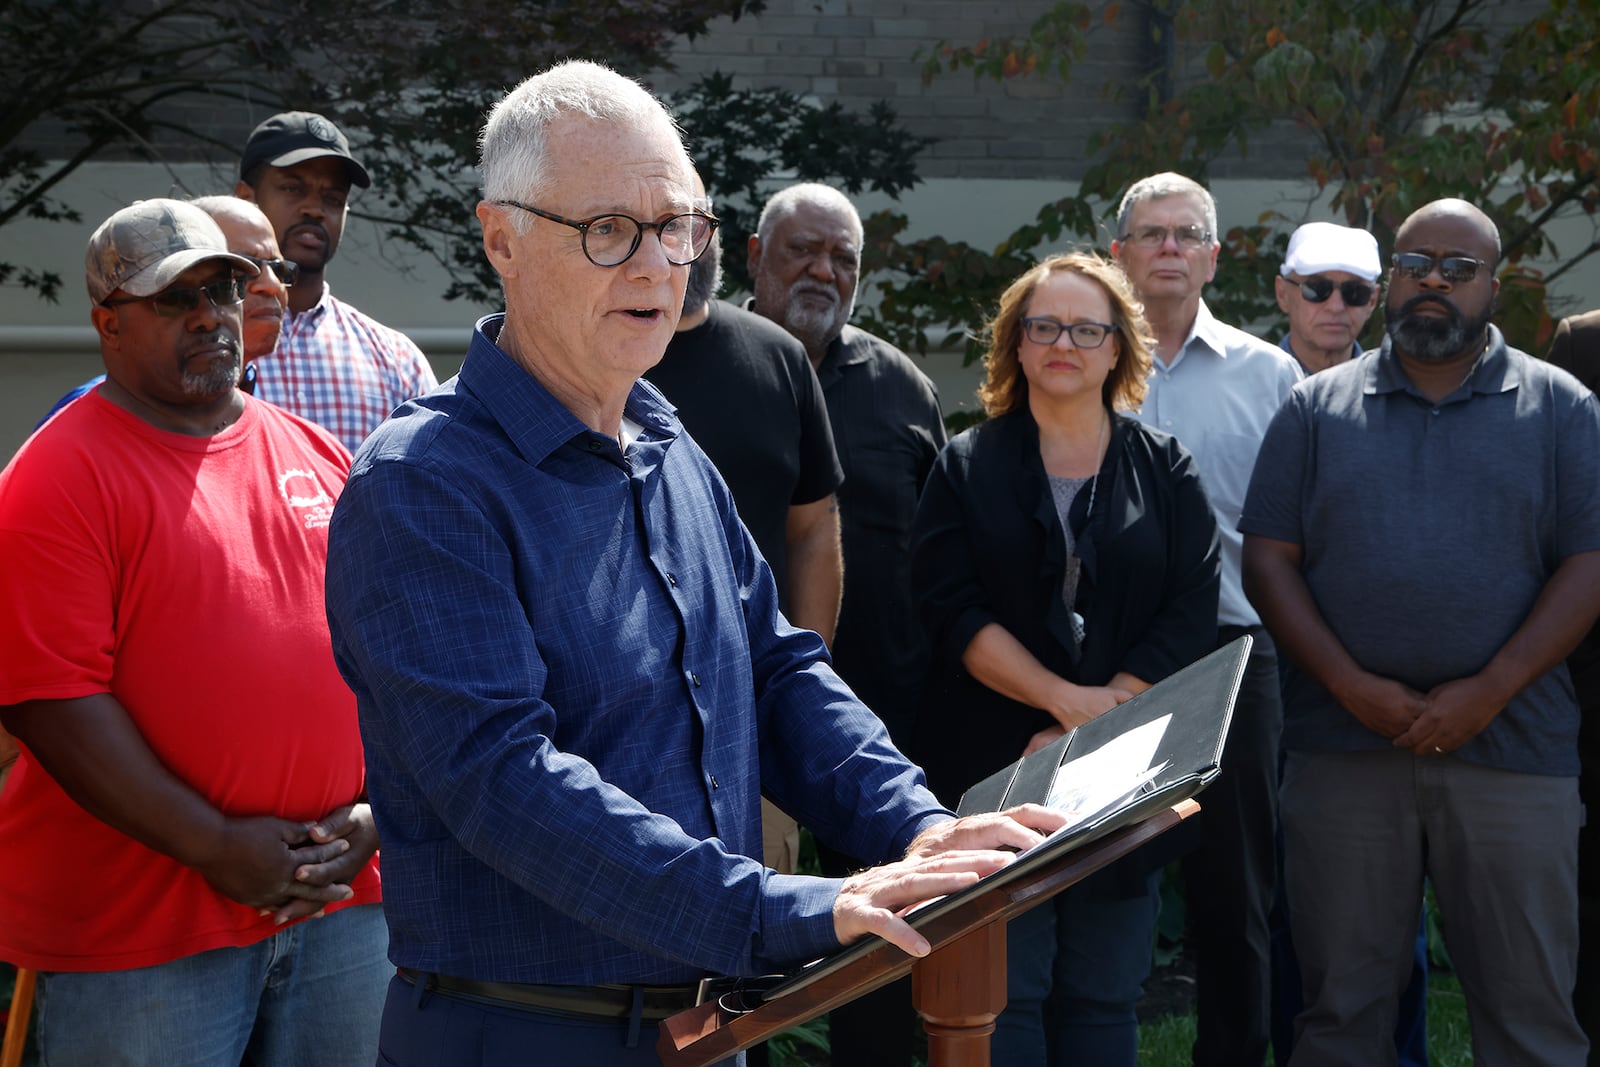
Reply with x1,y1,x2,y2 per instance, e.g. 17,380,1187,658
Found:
1240,200,1600,1067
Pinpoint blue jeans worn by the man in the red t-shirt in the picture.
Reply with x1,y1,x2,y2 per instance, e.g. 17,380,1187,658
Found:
34,904,394,1067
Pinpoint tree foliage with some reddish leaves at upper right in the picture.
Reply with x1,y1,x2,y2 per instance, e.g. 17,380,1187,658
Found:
872,0,1600,358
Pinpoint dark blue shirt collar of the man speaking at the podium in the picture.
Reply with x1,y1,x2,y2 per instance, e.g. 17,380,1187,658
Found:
461,312,678,464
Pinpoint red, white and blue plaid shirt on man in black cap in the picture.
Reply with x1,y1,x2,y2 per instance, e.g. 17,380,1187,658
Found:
256,285,438,453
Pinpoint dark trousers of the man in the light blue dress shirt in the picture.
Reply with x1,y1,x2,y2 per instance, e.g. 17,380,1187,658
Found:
1182,625,1283,1067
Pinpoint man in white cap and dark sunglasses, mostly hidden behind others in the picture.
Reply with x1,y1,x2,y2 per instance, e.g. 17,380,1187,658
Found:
1274,222,1382,374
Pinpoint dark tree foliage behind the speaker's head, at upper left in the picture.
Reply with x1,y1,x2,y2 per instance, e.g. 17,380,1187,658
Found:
0,0,923,302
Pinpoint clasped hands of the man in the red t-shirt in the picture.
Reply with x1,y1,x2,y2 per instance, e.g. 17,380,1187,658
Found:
194,803,378,925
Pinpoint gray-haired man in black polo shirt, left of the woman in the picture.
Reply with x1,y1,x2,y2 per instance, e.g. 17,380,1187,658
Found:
749,184,944,1067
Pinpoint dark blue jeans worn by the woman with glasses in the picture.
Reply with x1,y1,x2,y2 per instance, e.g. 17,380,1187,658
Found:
989,870,1162,1067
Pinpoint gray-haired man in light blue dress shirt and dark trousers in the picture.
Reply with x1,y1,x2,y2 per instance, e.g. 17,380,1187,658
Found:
1112,173,1301,1067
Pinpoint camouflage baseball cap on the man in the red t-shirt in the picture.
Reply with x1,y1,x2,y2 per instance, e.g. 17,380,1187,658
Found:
85,200,261,304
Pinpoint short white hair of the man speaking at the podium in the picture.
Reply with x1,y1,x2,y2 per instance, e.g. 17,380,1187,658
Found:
478,59,688,234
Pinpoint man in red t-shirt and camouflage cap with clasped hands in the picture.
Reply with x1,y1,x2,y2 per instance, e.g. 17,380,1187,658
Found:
0,200,394,1067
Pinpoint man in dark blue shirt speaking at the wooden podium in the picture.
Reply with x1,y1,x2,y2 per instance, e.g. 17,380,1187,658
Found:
328,62,1061,1065
